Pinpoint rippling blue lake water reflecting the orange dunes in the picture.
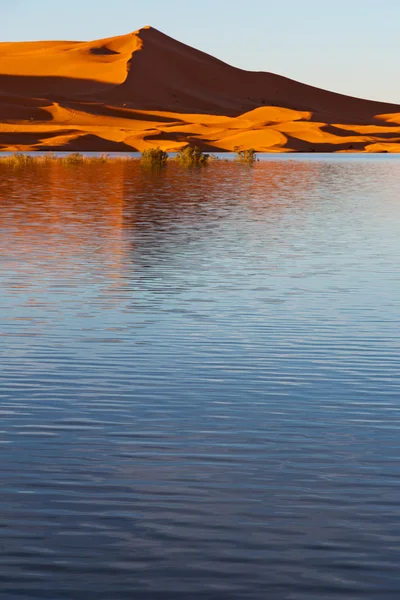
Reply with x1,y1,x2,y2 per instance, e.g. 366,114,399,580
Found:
0,157,400,600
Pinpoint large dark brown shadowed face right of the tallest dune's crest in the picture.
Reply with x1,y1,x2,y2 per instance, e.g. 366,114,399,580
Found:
97,28,399,123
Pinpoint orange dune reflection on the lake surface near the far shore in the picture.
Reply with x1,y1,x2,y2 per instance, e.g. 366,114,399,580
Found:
0,161,327,296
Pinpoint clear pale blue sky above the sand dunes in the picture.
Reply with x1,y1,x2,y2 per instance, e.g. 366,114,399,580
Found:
0,0,400,103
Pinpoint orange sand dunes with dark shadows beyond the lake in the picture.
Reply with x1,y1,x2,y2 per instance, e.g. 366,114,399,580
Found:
0,27,400,152
